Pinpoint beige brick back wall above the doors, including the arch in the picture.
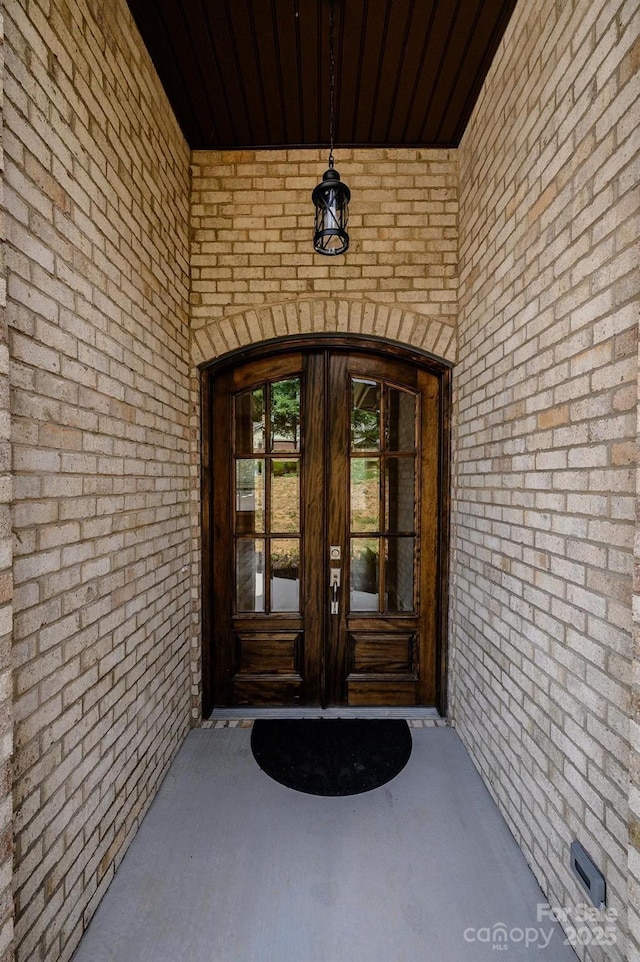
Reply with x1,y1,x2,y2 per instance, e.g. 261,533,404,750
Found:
191,150,458,364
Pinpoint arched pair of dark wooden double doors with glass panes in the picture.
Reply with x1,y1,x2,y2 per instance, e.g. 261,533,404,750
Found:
205,347,443,706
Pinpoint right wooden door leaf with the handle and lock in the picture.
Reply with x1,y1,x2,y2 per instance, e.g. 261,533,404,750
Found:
326,355,440,705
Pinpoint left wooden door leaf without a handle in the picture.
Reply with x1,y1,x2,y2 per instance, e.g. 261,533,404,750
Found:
212,354,321,705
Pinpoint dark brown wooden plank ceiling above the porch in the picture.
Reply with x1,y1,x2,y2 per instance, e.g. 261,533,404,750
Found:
129,0,516,149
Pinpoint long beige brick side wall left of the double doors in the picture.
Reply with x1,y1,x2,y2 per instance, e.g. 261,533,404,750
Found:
0,0,191,962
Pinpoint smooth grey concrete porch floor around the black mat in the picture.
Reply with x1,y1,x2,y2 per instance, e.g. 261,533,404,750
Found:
73,723,576,962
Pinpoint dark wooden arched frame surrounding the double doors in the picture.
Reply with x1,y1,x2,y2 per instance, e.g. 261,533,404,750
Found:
200,334,452,718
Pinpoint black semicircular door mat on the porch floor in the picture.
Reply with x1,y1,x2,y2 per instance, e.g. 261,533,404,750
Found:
251,718,411,796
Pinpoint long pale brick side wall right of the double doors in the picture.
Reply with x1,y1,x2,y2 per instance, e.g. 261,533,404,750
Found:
451,0,640,960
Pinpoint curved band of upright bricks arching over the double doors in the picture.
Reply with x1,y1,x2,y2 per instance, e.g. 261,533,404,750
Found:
192,297,457,366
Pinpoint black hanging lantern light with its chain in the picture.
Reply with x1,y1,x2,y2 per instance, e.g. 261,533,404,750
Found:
311,0,351,255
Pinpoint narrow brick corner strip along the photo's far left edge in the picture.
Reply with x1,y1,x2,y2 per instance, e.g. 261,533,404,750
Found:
0,8,13,962
